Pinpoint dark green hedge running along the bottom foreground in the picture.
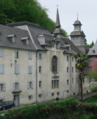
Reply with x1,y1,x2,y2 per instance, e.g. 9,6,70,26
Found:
3,98,97,119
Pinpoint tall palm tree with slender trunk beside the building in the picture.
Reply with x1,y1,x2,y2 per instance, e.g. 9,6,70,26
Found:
74,53,88,101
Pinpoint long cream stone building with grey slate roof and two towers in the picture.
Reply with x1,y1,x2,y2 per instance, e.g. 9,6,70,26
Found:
0,10,88,106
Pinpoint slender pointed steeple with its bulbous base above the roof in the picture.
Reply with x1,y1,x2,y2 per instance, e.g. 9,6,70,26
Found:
54,8,63,37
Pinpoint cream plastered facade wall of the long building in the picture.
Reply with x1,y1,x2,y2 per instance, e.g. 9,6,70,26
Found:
0,42,90,105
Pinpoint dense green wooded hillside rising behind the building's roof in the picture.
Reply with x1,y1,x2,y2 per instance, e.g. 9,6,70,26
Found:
0,0,67,37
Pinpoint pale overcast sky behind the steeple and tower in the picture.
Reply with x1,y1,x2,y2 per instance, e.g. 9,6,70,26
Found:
38,0,97,44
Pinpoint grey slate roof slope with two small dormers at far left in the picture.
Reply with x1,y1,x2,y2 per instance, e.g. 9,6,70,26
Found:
0,25,36,50
